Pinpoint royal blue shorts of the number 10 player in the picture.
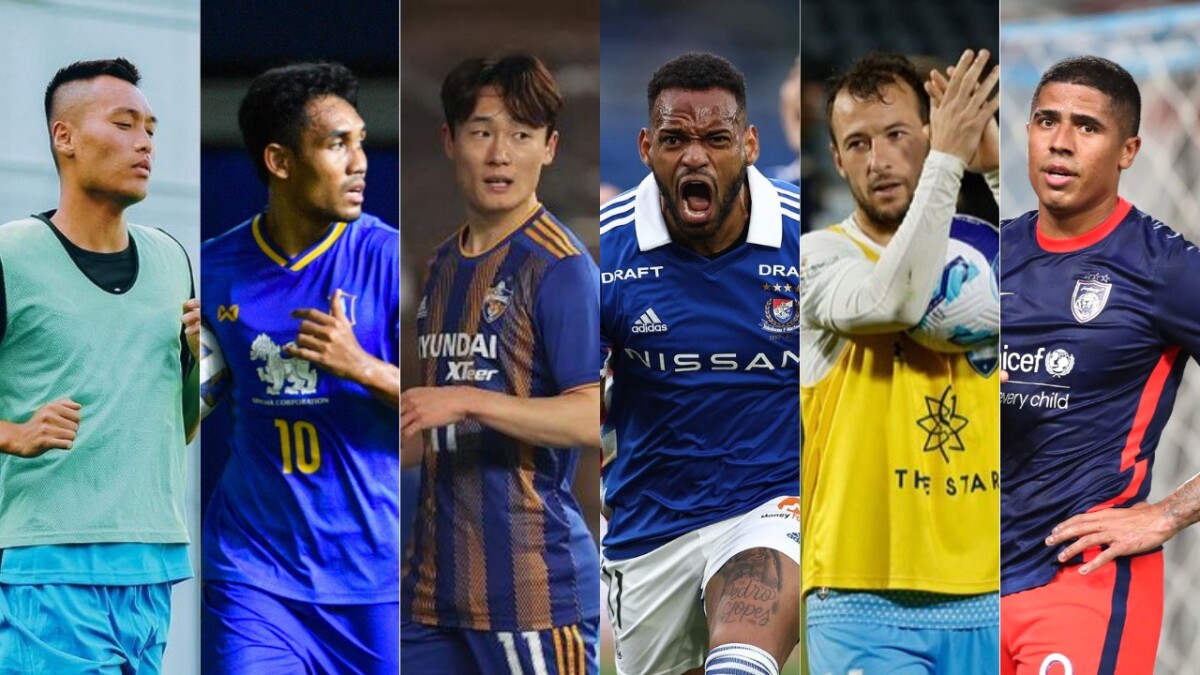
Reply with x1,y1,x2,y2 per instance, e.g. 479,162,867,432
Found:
200,581,400,675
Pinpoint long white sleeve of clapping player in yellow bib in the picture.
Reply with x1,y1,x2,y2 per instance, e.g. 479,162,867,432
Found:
800,151,965,334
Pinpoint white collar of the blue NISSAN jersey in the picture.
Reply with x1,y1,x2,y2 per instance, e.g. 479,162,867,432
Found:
634,166,784,251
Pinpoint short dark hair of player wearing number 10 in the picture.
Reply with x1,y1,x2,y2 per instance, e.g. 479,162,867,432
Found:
238,62,359,183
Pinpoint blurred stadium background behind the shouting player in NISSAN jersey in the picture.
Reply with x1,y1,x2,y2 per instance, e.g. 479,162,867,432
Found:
604,0,800,674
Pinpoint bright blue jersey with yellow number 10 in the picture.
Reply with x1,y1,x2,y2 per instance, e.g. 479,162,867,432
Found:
200,215,400,604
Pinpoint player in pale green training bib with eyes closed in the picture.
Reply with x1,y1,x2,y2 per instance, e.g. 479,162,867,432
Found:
0,59,200,675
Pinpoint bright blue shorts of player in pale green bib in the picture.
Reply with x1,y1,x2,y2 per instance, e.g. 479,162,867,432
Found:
0,583,170,675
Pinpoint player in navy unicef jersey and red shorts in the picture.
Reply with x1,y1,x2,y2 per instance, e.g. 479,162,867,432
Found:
1001,56,1200,675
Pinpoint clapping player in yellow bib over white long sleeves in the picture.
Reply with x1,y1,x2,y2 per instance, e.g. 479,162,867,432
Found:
800,50,1000,675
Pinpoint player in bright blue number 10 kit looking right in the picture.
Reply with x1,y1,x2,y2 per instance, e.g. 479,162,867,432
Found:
202,64,400,675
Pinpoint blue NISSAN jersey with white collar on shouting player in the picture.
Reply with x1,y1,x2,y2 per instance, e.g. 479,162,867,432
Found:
600,167,800,560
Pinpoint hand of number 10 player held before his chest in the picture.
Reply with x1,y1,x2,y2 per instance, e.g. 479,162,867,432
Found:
283,289,372,382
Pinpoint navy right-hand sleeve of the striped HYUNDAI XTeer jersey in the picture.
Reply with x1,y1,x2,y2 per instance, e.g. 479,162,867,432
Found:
534,251,601,392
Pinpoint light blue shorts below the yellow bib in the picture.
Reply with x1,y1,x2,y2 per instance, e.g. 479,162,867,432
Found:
805,592,1000,675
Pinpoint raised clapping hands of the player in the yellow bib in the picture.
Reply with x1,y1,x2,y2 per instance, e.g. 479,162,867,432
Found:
925,49,1000,162
